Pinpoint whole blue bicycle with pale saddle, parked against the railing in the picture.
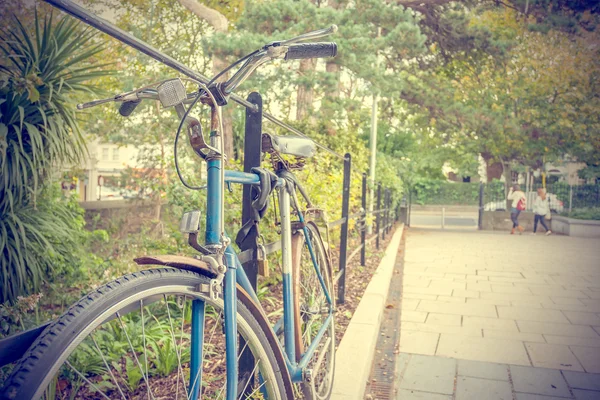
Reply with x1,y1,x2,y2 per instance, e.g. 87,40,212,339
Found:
3,22,337,400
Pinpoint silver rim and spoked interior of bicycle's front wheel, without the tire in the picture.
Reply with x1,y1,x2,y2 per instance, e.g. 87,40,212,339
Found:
28,285,279,399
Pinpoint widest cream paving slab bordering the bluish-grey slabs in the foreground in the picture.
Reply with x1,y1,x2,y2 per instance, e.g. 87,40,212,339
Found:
436,333,530,365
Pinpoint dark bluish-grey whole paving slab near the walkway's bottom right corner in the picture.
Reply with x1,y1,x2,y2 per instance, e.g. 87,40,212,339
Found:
510,365,571,398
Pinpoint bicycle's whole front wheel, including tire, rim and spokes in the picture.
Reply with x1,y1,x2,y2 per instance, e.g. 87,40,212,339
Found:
3,268,287,400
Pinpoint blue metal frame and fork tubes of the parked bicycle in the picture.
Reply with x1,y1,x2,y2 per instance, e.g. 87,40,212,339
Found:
190,152,333,400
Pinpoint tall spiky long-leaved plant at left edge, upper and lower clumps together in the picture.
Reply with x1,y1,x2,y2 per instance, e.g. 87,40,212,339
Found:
0,12,107,301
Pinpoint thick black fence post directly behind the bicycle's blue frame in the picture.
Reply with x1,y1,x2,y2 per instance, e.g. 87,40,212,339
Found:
239,92,262,390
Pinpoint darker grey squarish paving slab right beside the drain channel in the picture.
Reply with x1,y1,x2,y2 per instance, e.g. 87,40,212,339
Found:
398,356,456,395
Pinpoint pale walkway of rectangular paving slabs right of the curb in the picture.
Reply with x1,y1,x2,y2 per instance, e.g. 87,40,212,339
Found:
396,229,600,400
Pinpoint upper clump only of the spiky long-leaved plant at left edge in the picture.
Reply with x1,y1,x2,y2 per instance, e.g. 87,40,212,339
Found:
0,10,106,202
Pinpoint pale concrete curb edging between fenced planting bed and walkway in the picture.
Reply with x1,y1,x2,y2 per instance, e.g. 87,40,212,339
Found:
331,225,404,400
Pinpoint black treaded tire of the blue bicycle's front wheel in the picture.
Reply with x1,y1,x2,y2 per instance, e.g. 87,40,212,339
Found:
2,268,288,400
